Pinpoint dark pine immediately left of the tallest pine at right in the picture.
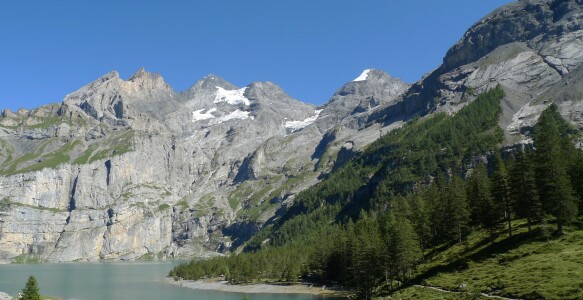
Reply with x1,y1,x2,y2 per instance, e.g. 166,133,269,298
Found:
509,151,542,232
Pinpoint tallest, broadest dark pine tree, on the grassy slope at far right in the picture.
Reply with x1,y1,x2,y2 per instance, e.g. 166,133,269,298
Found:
534,104,577,235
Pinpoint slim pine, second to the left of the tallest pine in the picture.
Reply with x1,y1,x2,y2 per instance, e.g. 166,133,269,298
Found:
492,150,512,236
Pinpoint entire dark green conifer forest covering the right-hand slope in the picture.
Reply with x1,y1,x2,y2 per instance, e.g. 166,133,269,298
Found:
170,87,583,299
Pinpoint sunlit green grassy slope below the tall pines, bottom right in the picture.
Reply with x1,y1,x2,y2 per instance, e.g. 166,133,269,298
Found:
390,220,583,299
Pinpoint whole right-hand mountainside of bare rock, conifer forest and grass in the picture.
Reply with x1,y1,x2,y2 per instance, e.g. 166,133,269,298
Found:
170,0,583,299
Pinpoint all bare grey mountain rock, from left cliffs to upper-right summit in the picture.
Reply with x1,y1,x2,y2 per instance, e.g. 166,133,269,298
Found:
0,0,583,261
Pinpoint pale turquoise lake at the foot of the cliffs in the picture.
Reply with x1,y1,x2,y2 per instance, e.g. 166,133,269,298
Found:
0,261,342,300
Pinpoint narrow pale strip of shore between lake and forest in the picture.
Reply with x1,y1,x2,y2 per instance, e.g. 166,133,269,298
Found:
167,278,347,297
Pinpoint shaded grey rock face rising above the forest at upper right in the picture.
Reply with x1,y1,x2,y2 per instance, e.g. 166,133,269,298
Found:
375,0,583,143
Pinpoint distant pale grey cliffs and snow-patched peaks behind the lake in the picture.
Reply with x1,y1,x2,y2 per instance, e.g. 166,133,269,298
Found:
0,65,407,261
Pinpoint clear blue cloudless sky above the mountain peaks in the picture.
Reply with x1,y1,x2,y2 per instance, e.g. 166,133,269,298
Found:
0,0,510,110
